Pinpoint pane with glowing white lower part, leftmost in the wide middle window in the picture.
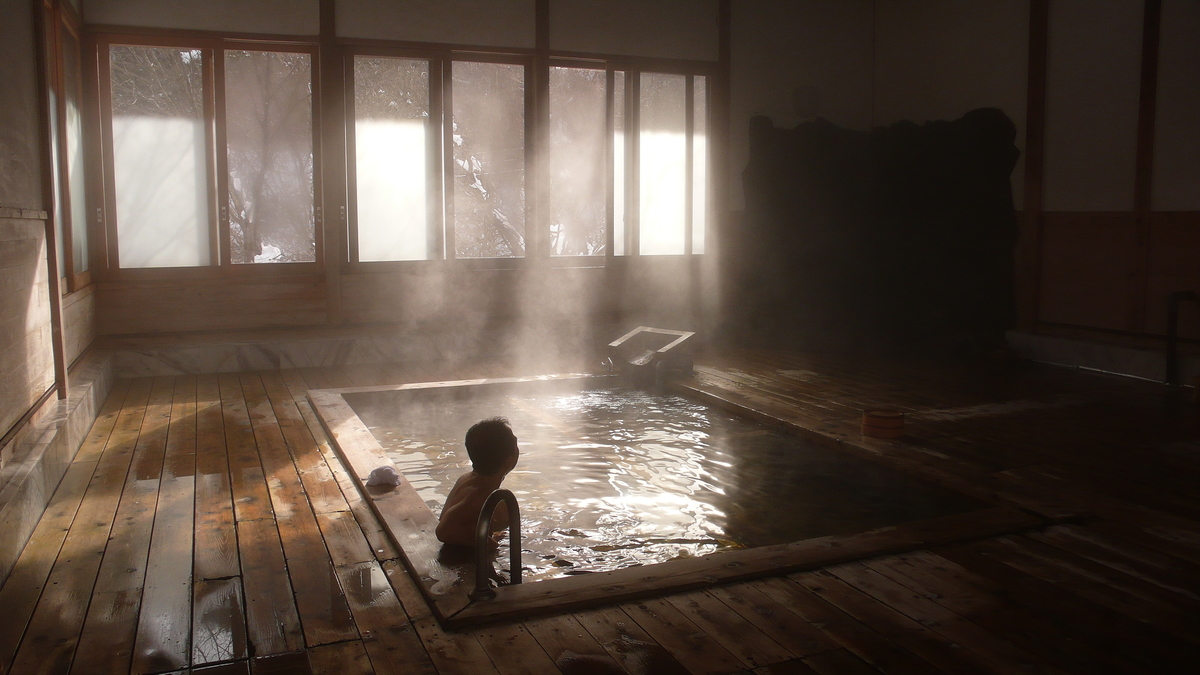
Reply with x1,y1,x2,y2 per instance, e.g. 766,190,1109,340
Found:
354,56,432,261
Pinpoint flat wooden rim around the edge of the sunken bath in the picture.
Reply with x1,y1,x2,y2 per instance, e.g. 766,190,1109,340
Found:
307,374,1048,628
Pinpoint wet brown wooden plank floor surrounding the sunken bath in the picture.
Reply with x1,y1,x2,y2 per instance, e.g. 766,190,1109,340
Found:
0,352,1200,675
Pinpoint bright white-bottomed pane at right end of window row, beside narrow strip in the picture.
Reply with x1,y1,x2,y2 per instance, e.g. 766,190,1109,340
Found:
638,73,688,256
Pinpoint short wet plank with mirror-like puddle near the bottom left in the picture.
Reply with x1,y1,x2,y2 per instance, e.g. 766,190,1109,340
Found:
192,578,248,665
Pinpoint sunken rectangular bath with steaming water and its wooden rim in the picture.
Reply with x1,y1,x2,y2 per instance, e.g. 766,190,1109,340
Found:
308,375,1039,627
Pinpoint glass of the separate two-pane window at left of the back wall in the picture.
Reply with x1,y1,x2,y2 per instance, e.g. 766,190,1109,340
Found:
102,41,318,269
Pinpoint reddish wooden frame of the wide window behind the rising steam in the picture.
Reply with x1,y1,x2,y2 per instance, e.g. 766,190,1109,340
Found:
341,45,720,274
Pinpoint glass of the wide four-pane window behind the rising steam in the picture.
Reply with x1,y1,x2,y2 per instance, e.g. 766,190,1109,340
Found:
348,55,710,262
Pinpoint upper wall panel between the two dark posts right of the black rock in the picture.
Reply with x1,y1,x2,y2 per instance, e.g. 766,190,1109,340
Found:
1043,0,1142,211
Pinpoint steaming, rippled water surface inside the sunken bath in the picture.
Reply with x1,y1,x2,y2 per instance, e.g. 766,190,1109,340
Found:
346,389,985,579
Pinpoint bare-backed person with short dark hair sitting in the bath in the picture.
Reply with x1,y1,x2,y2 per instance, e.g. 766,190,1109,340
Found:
434,417,521,548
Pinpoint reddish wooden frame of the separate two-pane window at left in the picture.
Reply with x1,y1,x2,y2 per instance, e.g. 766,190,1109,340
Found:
88,31,325,281
